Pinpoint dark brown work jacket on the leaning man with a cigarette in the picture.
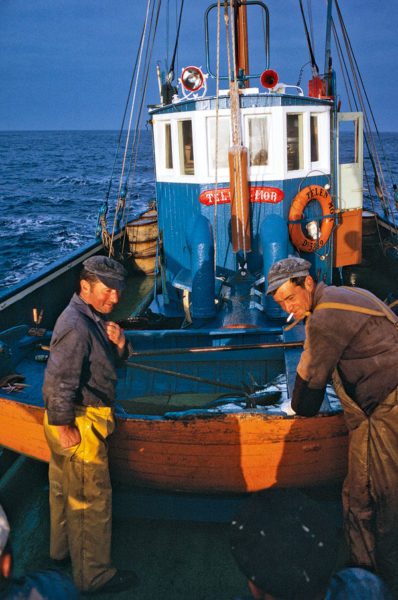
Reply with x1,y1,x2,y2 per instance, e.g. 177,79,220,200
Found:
292,283,398,416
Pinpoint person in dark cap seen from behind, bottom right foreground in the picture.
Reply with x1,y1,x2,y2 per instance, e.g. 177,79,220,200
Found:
230,488,393,600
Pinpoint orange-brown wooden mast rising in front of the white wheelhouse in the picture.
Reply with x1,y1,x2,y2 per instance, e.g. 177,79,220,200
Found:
225,0,251,253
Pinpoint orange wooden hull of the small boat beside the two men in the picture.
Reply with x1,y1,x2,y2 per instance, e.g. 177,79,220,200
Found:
0,397,347,494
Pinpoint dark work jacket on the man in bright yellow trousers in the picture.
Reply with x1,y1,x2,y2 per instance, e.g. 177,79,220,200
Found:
43,294,130,425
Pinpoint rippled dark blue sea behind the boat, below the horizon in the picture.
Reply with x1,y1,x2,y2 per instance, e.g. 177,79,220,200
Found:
0,130,398,289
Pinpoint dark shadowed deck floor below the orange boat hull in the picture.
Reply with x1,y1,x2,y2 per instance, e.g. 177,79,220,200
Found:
0,448,341,600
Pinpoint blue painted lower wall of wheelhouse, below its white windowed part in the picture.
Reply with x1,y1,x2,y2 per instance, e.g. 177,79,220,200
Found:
157,174,332,314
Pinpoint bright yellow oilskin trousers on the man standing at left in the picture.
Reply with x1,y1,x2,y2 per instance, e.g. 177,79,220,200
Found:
44,406,116,591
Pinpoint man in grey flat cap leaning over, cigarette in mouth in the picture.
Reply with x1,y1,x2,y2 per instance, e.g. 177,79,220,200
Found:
267,257,398,596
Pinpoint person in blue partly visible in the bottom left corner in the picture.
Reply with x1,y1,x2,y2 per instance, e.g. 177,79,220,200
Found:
0,505,79,600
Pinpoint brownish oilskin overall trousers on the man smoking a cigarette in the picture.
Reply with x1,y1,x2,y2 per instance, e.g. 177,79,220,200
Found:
333,370,398,597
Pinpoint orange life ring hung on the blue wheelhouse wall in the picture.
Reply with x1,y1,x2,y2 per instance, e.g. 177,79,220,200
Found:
289,185,335,252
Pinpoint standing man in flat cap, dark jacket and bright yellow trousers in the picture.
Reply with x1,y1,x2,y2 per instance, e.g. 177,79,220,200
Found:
43,256,135,593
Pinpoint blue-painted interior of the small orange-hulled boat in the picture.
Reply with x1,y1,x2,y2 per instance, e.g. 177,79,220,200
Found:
0,326,341,418
